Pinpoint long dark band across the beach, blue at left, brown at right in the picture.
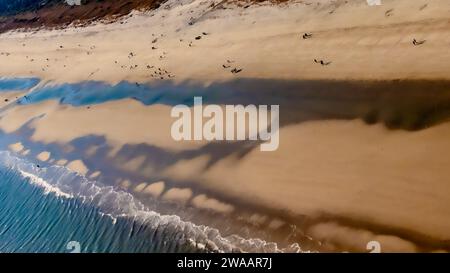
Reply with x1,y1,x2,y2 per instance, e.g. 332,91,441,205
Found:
17,79,450,130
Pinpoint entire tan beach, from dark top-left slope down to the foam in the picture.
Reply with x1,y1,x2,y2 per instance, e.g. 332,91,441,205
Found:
0,0,450,252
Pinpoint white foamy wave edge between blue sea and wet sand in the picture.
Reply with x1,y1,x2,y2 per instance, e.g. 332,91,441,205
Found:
0,151,302,252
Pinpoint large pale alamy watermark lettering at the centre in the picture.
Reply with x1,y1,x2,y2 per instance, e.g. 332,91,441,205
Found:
170,97,280,152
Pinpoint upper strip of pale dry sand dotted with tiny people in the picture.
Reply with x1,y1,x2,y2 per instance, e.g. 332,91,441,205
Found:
0,0,450,82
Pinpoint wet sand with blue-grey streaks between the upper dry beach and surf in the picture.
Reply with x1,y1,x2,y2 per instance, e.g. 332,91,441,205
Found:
0,77,450,251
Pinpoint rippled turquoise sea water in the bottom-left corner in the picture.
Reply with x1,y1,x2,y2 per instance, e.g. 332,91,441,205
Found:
0,152,202,253
